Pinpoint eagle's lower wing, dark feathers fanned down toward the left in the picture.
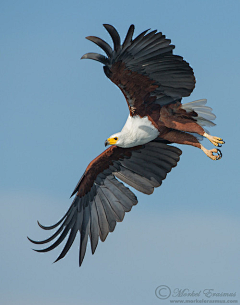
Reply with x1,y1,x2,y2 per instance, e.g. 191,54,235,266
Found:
29,140,181,265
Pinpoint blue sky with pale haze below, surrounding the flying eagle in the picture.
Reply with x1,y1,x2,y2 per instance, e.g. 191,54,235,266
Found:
0,0,240,305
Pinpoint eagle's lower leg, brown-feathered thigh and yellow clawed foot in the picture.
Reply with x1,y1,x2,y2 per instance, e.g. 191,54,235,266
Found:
159,128,222,160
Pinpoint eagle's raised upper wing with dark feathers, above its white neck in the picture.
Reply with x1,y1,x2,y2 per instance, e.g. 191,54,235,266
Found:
82,24,195,117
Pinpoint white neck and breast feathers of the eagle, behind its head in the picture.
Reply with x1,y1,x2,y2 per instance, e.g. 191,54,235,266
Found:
118,115,159,147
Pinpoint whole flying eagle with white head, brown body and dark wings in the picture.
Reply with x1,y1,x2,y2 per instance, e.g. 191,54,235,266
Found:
29,24,224,265
